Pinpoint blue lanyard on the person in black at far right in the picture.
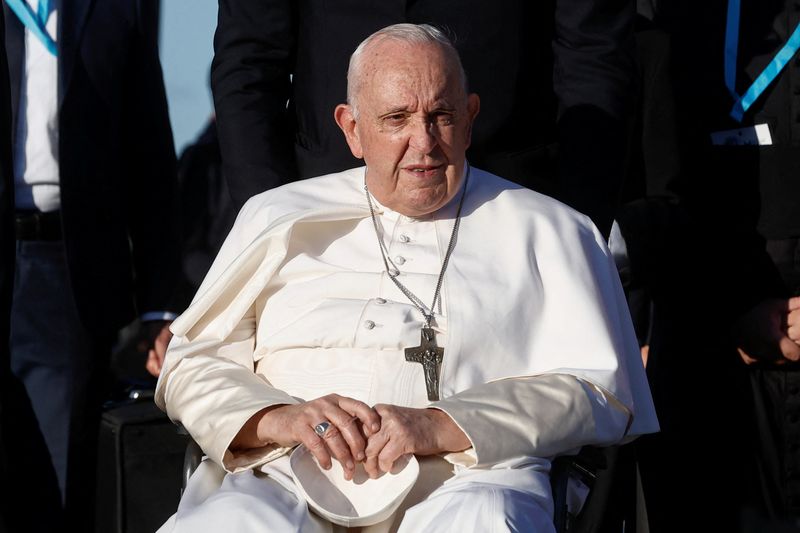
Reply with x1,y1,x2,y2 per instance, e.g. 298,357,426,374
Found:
725,0,800,122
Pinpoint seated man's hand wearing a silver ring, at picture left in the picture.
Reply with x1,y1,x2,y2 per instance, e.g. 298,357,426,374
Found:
231,394,381,479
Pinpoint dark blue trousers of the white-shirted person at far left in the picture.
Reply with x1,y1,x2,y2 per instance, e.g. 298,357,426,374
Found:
3,241,111,531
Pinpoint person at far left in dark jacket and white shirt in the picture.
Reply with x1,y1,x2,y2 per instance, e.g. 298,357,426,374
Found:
3,0,179,531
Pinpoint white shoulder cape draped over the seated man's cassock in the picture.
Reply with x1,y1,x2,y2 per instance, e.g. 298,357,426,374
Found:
162,168,658,436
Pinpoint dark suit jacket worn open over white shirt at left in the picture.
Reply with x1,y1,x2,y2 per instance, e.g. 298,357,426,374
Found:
4,0,180,331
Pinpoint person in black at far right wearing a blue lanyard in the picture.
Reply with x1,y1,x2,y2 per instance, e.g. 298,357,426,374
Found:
656,0,800,531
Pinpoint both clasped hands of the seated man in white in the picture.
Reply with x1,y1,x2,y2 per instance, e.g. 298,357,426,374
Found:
245,394,470,479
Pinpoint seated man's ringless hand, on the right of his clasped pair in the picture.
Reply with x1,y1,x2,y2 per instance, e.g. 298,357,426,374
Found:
364,404,472,479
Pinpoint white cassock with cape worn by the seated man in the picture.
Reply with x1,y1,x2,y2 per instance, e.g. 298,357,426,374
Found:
156,164,658,532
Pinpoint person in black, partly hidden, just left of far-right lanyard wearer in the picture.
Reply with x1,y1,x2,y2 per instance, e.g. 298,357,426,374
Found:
617,9,744,533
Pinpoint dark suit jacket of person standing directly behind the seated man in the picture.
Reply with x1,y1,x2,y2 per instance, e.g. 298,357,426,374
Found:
212,0,634,237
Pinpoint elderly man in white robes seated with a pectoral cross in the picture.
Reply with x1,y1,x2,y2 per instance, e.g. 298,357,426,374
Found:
157,24,657,532
